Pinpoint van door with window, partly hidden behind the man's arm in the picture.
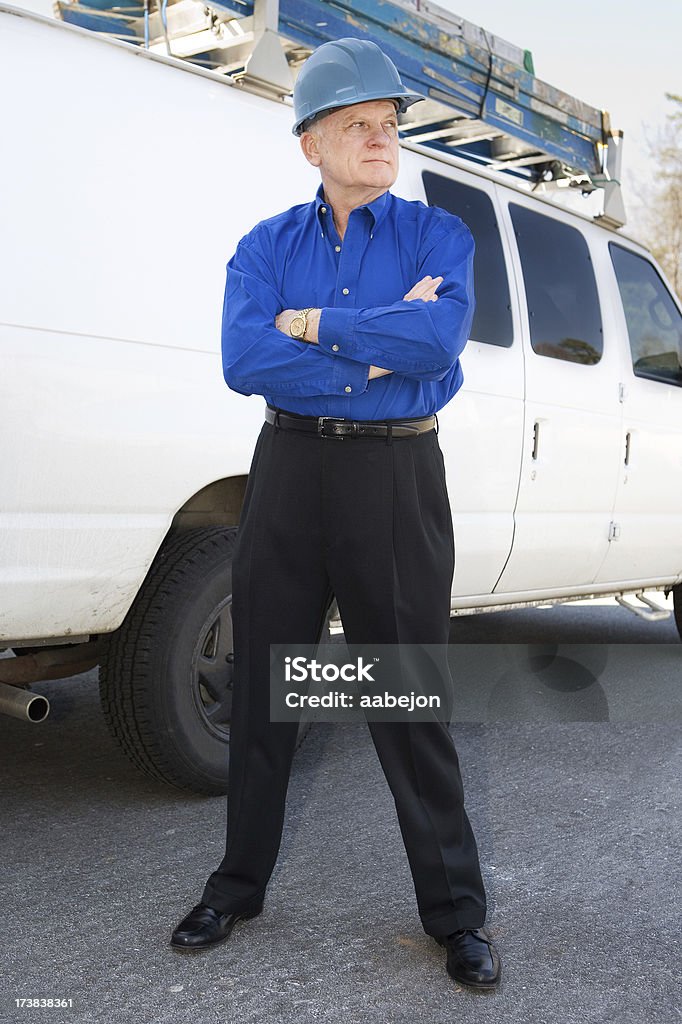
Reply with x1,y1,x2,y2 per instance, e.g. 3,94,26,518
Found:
423,169,523,606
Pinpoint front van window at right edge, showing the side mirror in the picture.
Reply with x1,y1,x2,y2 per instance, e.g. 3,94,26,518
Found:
608,242,682,384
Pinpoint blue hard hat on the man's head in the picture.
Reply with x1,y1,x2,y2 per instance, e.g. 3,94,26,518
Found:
292,38,425,135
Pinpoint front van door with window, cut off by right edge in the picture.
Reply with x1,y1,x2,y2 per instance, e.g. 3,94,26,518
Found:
597,242,682,583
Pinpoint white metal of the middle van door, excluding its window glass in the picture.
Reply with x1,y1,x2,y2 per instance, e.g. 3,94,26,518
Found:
485,189,623,594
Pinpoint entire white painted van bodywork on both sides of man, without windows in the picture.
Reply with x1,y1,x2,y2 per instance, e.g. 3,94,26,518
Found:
0,8,682,641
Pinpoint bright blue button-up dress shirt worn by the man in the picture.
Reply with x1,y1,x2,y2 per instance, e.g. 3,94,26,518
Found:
222,184,474,420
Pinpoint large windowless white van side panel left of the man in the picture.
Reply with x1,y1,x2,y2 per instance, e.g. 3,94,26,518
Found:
0,13,278,639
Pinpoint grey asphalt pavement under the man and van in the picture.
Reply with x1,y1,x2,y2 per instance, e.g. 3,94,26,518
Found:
0,604,682,1024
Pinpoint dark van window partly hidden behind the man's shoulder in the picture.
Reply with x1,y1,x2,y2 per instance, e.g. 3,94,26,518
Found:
423,171,514,348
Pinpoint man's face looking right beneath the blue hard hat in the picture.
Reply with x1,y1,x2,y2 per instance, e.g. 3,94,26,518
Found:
300,99,398,195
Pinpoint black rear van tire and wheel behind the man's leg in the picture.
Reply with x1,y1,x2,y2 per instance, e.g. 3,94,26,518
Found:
99,526,309,796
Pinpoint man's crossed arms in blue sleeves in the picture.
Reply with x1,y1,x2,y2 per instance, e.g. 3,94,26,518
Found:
222,223,474,399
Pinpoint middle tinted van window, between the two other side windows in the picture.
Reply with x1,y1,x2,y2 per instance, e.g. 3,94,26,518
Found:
509,203,604,364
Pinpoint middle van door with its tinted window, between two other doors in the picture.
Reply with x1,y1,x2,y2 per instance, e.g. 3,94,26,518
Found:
495,197,622,596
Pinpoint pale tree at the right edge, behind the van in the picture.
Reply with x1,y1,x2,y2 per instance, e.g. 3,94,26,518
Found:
646,92,682,295
